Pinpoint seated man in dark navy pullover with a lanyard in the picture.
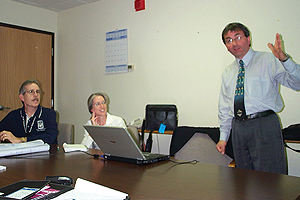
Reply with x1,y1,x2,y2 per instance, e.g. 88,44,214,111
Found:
0,80,58,144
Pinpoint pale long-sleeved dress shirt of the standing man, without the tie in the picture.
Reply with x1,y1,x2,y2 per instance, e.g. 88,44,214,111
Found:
218,49,300,141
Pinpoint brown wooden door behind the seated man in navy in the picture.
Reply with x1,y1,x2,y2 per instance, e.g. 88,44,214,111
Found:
0,23,54,120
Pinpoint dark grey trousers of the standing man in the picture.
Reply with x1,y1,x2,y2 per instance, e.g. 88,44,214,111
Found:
232,114,286,174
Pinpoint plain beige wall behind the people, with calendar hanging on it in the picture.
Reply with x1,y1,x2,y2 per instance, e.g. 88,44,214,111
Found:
0,0,300,142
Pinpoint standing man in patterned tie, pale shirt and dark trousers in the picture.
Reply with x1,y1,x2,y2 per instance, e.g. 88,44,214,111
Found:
216,23,300,174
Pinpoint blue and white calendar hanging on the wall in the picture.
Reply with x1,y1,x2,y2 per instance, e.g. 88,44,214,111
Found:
105,29,128,74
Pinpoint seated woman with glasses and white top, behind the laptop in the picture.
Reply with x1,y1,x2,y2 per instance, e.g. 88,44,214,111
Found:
81,92,126,149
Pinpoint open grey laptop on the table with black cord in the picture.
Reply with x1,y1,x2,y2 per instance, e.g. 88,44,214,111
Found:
83,125,170,164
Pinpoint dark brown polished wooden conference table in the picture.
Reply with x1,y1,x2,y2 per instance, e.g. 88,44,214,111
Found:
0,145,300,200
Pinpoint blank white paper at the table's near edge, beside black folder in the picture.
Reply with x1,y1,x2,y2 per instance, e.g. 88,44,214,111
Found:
54,178,129,200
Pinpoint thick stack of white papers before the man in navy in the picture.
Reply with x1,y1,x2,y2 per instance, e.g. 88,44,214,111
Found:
0,140,50,157
